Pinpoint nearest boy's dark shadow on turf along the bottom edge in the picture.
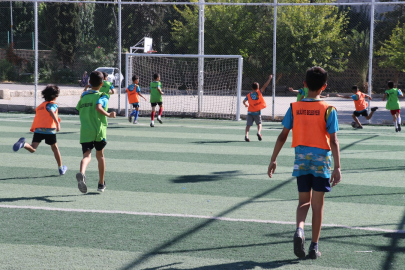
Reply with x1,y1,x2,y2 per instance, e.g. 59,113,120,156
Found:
144,259,299,270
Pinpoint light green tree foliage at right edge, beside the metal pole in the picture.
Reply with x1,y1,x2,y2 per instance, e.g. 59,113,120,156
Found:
376,23,405,72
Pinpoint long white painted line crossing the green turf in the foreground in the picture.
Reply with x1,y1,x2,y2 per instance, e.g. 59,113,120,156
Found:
0,204,405,233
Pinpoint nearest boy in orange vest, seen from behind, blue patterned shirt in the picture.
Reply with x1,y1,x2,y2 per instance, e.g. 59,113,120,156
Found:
267,67,341,259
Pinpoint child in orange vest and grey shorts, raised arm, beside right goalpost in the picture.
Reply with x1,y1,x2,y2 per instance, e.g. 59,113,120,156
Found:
243,75,273,142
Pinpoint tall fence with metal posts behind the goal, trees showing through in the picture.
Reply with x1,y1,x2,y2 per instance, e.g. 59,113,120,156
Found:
0,0,405,121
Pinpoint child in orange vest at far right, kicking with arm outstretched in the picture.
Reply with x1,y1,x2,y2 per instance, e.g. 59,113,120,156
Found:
336,85,378,129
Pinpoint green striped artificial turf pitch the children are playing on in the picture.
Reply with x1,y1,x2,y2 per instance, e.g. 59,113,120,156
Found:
0,114,405,270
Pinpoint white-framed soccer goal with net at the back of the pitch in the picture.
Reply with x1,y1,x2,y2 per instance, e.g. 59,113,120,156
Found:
125,53,243,120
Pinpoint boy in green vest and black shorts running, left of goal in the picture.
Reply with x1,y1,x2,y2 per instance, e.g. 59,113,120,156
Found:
76,71,116,193
